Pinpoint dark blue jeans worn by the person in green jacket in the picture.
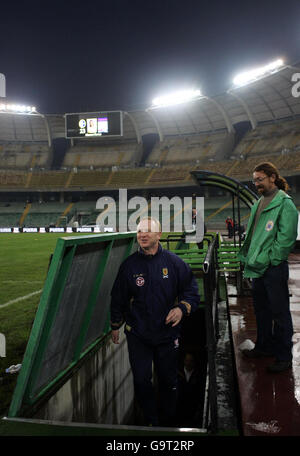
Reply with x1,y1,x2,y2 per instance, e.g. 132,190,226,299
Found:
252,261,293,361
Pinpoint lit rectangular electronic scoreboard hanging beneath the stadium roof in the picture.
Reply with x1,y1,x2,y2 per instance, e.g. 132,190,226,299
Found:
65,111,123,138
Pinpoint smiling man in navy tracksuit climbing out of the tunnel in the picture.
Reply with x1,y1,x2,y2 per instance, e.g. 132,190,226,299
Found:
111,218,200,426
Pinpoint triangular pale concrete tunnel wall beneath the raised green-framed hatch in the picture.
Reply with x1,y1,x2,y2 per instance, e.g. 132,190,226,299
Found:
33,330,134,424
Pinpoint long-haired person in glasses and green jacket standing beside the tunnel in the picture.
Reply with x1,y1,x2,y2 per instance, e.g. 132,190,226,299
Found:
238,162,298,372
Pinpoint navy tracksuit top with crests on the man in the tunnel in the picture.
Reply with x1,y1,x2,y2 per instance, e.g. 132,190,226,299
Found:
111,244,200,344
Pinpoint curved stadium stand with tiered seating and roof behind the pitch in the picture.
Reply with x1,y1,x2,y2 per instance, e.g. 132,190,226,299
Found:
0,62,300,230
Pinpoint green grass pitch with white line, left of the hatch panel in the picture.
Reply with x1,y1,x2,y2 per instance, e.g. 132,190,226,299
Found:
0,233,94,416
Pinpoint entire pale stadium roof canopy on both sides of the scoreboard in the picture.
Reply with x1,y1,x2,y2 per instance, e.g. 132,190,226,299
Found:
0,66,300,144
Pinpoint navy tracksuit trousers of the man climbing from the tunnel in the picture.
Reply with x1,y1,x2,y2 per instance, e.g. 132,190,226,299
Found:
126,332,178,426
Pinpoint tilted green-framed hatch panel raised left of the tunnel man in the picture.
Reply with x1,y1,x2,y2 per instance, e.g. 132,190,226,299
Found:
8,233,137,417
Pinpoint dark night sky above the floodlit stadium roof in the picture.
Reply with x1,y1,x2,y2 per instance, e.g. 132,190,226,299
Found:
0,0,300,114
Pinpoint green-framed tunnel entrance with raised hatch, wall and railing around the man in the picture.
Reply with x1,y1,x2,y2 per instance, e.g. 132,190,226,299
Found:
4,216,245,434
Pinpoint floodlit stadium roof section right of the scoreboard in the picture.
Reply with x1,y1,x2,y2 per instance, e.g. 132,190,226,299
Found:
130,66,300,139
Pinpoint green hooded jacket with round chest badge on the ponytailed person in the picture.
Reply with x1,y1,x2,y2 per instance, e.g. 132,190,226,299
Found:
238,190,298,278
